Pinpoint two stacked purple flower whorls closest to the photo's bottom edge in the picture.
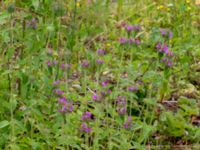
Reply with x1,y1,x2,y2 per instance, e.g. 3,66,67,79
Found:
80,111,92,133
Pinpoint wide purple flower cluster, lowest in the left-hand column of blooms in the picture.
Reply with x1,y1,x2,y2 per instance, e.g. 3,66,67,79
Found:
58,97,73,113
